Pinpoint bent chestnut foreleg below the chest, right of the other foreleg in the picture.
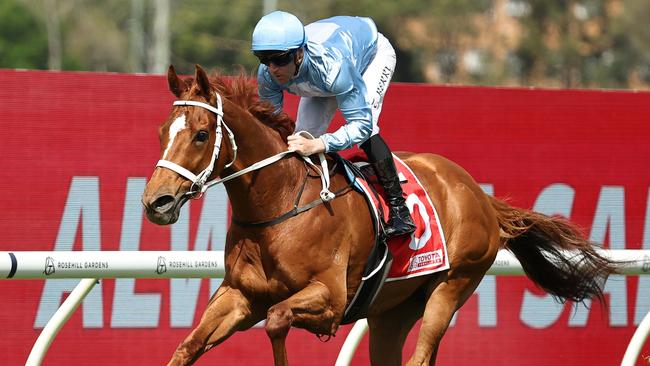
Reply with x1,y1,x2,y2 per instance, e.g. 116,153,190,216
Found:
266,281,336,366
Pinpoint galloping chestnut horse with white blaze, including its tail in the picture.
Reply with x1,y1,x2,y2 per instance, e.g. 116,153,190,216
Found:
142,65,615,365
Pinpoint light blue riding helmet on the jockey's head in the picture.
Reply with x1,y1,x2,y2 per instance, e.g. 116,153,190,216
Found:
251,11,307,51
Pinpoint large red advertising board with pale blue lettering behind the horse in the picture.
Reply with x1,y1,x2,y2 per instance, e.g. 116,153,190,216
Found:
0,70,650,366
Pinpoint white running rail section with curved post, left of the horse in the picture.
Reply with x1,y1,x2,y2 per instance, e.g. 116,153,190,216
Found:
0,251,225,366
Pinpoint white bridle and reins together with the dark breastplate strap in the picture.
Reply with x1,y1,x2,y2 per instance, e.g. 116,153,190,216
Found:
156,92,340,223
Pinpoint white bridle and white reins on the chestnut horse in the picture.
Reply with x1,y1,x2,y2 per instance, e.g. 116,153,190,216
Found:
156,92,336,202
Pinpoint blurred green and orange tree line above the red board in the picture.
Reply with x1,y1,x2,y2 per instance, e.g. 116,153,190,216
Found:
0,0,650,89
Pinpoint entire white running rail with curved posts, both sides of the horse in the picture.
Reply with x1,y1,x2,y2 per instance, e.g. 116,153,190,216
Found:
0,250,650,366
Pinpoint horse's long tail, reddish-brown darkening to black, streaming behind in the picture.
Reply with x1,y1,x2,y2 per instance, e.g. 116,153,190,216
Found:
490,197,616,303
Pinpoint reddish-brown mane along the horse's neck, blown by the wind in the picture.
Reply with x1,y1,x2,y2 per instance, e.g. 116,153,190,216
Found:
185,72,296,141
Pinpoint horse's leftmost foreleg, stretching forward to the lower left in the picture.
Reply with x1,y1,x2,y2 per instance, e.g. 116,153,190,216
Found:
168,285,261,366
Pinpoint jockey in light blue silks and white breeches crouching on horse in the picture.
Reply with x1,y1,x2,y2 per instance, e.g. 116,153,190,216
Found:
252,11,415,237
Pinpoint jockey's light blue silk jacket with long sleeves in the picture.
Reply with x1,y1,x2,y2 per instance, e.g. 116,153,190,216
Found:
257,16,377,152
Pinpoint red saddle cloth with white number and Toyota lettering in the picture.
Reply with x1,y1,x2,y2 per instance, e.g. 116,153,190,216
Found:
357,155,449,281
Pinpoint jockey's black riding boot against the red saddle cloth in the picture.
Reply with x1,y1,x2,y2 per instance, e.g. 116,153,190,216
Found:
372,157,415,238
